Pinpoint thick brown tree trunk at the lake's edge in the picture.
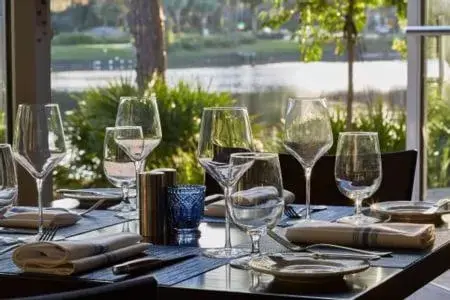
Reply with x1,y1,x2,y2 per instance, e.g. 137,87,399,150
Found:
127,0,167,91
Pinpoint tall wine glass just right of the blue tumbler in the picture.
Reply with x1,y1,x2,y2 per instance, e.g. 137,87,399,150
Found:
197,107,253,258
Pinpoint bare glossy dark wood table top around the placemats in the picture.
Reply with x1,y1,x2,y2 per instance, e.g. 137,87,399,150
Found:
0,210,450,299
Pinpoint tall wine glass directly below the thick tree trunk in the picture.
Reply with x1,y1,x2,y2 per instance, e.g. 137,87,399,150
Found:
116,95,162,218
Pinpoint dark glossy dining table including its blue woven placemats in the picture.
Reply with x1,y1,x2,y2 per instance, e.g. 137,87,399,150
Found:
0,206,450,299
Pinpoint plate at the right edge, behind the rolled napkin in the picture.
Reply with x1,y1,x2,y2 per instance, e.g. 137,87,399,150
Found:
370,201,450,223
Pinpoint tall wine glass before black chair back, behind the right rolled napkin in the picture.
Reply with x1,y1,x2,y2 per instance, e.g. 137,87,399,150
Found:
283,97,333,222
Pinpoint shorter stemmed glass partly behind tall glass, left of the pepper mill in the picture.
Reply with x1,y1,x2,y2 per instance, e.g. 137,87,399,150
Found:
103,127,136,217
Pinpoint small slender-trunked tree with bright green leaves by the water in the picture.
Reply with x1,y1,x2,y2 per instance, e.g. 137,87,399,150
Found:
262,0,406,130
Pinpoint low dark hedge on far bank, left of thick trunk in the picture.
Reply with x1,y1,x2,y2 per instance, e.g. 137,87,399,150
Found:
52,32,131,45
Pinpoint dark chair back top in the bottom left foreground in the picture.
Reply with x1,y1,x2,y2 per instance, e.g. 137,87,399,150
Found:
15,276,158,300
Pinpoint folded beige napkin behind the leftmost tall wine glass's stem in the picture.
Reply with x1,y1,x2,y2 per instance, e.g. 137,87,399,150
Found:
0,206,81,228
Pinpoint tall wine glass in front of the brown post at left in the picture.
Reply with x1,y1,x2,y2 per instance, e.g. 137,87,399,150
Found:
12,104,66,237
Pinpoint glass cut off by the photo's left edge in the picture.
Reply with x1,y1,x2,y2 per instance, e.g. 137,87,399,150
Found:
0,144,17,214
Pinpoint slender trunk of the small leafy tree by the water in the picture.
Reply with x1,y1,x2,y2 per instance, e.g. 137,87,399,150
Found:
345,0,356,131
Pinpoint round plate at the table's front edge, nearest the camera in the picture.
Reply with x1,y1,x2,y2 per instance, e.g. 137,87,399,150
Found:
249,253,370,282
